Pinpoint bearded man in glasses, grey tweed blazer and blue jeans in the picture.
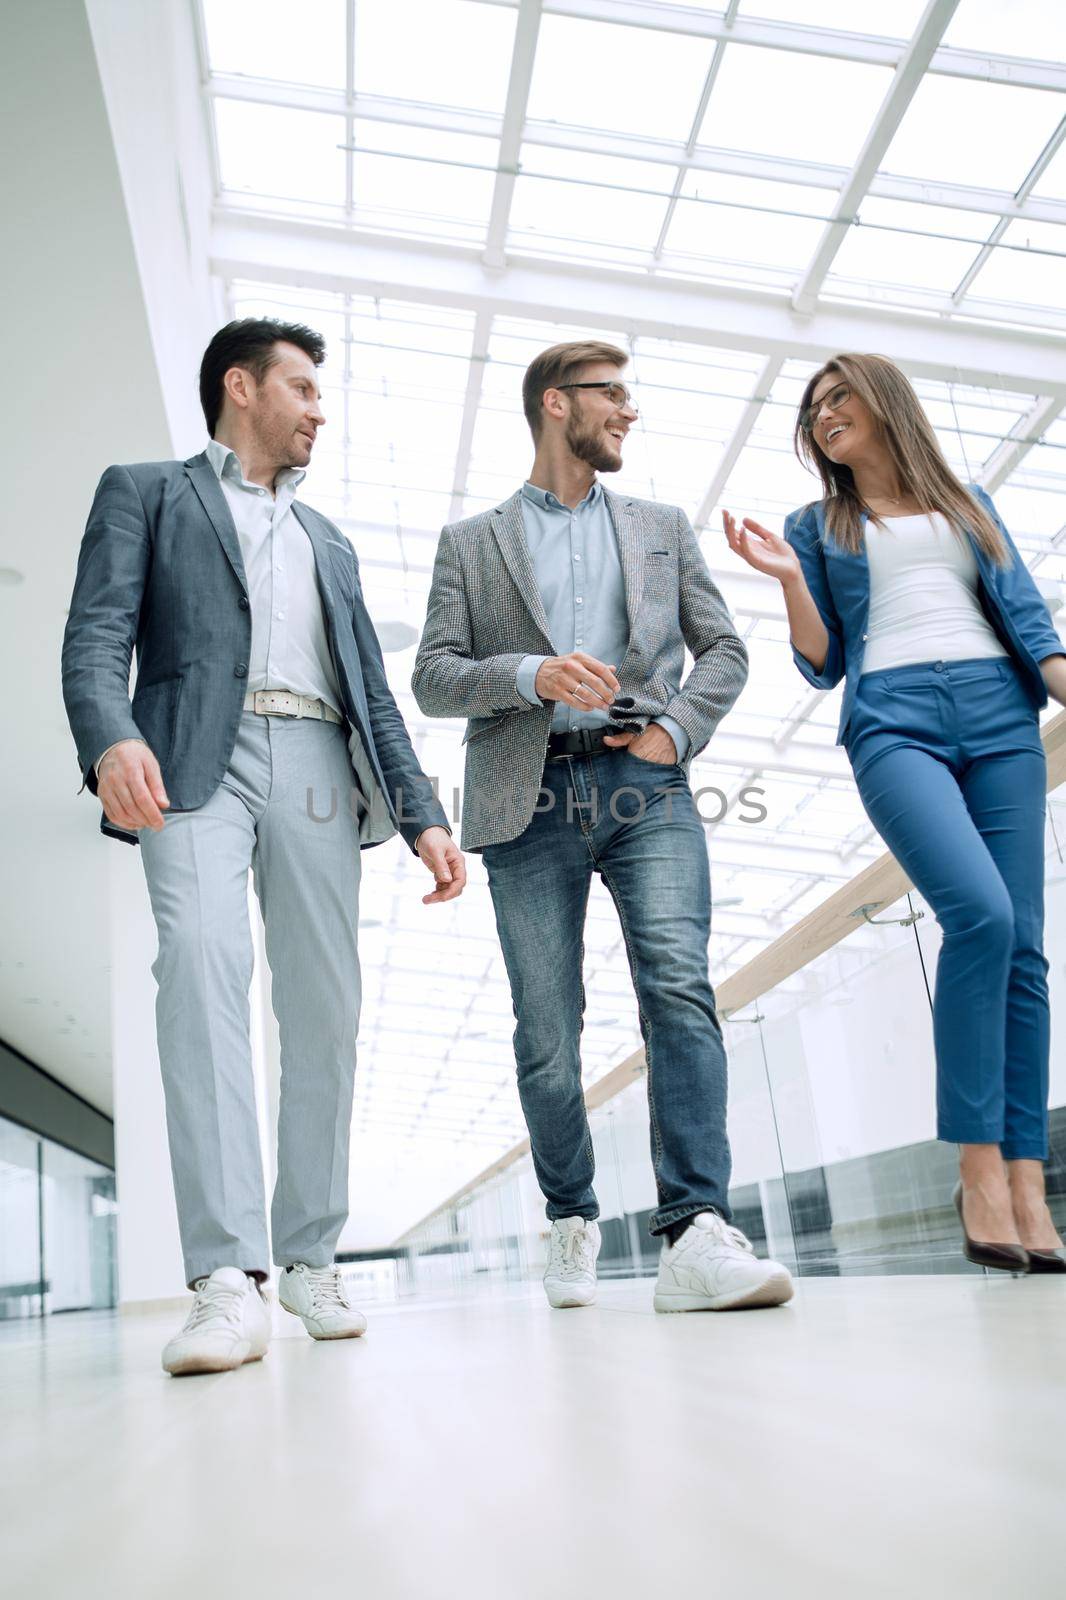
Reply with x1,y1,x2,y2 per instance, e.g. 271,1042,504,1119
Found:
413,341,792,1310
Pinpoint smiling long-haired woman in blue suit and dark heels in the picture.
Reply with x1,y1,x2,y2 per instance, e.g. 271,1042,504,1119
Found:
725,355,1066,1272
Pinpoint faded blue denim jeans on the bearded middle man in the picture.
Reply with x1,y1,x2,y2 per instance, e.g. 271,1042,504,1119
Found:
483,750,730,1234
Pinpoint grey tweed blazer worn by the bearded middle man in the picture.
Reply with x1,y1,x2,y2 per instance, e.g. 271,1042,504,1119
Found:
411,491,747,850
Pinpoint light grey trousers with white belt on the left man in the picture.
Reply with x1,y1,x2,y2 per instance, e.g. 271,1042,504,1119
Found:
141,712,360,1285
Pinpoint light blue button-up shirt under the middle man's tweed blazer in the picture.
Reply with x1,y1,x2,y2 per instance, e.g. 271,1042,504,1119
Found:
515,483,688,762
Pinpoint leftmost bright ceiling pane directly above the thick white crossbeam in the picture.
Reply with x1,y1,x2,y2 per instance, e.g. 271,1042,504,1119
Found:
214,99,346,210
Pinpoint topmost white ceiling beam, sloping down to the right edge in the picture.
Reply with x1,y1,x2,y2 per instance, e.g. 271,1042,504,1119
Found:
482,0,1066,93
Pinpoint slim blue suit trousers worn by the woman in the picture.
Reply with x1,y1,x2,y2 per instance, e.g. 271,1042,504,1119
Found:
845,659,1050,1160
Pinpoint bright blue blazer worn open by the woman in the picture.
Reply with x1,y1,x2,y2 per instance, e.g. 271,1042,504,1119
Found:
784,483,1066,744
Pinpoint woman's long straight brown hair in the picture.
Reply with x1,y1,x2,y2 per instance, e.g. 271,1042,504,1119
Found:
795,354,1010,566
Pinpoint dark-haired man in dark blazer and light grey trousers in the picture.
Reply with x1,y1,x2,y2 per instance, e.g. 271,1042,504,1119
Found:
62,318,466,1373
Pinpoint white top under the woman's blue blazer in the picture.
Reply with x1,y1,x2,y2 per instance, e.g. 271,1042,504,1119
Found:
863,512,1007,672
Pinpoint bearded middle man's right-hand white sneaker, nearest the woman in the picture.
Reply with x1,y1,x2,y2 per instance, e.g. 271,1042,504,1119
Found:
655,1211,792,1310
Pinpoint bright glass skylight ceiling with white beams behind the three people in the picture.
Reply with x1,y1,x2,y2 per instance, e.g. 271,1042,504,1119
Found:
202,0,1066,1176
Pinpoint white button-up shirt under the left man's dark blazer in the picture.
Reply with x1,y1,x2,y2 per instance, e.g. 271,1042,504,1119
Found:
206,438,341,712
